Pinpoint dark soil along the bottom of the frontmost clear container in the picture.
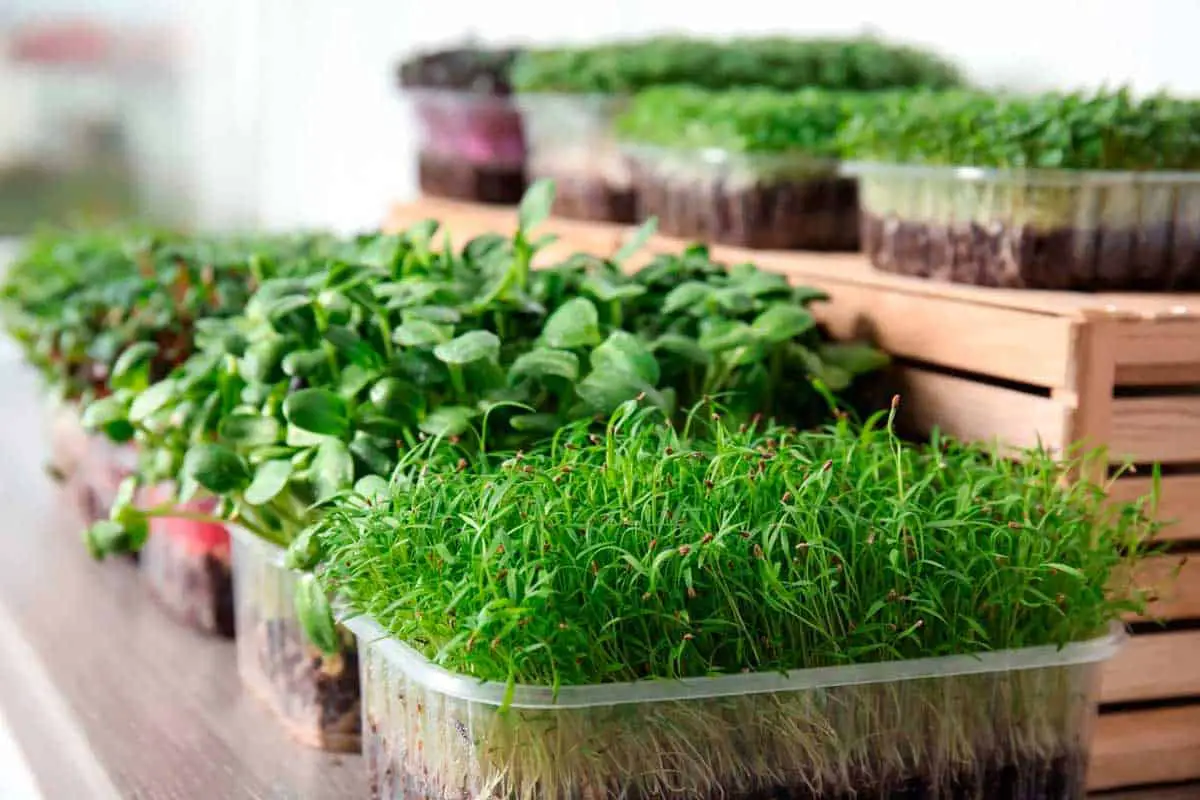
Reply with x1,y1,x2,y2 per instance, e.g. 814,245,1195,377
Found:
365,734,1087,800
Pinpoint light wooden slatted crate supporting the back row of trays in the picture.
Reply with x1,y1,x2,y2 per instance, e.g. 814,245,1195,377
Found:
389,200,1200,796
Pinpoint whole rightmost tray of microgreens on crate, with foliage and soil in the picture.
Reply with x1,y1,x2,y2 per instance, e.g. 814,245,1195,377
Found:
845,92,1200,291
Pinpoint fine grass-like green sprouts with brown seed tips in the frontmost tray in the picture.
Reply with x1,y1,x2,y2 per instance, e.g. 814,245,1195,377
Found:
314,403,1156,686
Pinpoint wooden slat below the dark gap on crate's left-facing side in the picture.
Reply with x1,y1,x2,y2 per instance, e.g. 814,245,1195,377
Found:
896,367,1070,451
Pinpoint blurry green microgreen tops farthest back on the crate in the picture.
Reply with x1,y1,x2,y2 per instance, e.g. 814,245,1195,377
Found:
512,37,962,94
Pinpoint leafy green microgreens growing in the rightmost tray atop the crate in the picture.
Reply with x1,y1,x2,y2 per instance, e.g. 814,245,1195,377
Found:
842,90,1200,170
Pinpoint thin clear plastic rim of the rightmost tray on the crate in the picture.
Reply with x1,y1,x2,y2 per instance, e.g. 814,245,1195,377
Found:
841,161,1200,186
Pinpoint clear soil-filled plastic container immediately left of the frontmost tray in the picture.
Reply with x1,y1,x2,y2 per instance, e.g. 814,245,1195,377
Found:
230,527,362,752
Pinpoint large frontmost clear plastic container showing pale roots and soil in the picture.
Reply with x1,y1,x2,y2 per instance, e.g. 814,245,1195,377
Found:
346,616,1124,800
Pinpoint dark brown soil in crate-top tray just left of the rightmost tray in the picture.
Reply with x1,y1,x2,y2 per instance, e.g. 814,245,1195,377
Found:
635,169,859,252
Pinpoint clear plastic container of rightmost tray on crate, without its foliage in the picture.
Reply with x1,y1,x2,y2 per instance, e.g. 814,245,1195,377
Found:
847,163,1200,291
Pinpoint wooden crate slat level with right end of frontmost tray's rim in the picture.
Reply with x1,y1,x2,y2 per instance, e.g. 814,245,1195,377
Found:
1100,631,1200,703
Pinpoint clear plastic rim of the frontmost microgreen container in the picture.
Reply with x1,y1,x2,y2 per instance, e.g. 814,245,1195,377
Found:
340,614,1128,709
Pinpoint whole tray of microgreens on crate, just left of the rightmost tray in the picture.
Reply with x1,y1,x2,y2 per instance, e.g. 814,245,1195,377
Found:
618,89,864,252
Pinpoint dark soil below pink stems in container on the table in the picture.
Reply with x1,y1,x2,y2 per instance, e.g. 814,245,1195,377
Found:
143,544,234,639
